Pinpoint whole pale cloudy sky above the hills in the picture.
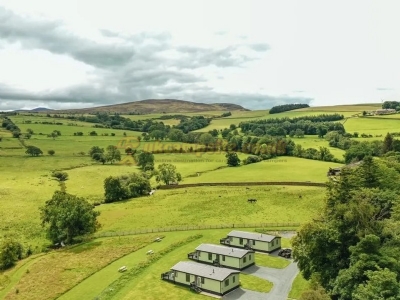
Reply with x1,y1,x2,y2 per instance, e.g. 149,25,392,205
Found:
0,0,400,110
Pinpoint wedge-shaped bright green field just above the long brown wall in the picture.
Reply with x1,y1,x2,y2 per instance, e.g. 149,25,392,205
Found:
184,156,342,183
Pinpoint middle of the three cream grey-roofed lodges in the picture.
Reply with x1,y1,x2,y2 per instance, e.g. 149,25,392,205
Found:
188,244,255,270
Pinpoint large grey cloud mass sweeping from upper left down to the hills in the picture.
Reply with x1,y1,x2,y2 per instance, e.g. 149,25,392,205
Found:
0,7,280,110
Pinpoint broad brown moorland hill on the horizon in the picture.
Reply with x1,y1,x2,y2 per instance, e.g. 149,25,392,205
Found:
54,99,248,114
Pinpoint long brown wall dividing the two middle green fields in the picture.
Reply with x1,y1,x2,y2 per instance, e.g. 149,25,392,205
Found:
158,181,326,190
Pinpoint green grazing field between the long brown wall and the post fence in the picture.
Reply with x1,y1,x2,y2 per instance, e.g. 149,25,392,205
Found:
97,186,325,232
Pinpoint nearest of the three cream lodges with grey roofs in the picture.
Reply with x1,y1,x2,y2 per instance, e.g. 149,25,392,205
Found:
161,261,240,296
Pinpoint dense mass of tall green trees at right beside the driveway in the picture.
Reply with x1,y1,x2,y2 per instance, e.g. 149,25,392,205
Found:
292,156,400,300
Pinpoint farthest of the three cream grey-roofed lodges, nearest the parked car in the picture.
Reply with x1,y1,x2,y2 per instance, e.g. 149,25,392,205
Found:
220,230,281,253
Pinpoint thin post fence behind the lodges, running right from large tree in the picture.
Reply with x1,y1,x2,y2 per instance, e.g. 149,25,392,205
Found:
93,223,301,238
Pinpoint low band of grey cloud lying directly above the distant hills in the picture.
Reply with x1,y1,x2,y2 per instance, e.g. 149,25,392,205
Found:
0,83,313,110
